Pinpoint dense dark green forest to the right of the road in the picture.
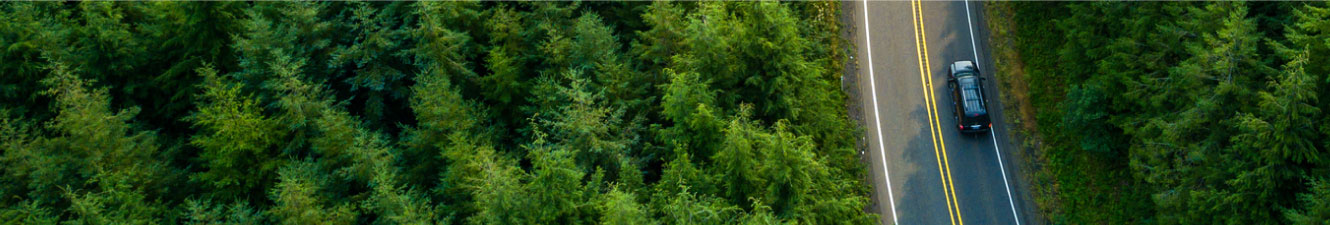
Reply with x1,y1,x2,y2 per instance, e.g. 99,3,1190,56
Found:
998,1,1330,225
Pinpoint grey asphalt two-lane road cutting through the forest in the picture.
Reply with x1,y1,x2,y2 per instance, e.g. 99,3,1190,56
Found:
845,1,1037,225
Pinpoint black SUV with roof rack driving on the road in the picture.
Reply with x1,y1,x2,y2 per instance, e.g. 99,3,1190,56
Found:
947,61,994,133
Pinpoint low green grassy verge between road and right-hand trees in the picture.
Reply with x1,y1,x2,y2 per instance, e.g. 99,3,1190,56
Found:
983,1,1153,224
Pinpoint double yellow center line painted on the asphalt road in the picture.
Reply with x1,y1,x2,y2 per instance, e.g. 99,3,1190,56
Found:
910,0,966,225
